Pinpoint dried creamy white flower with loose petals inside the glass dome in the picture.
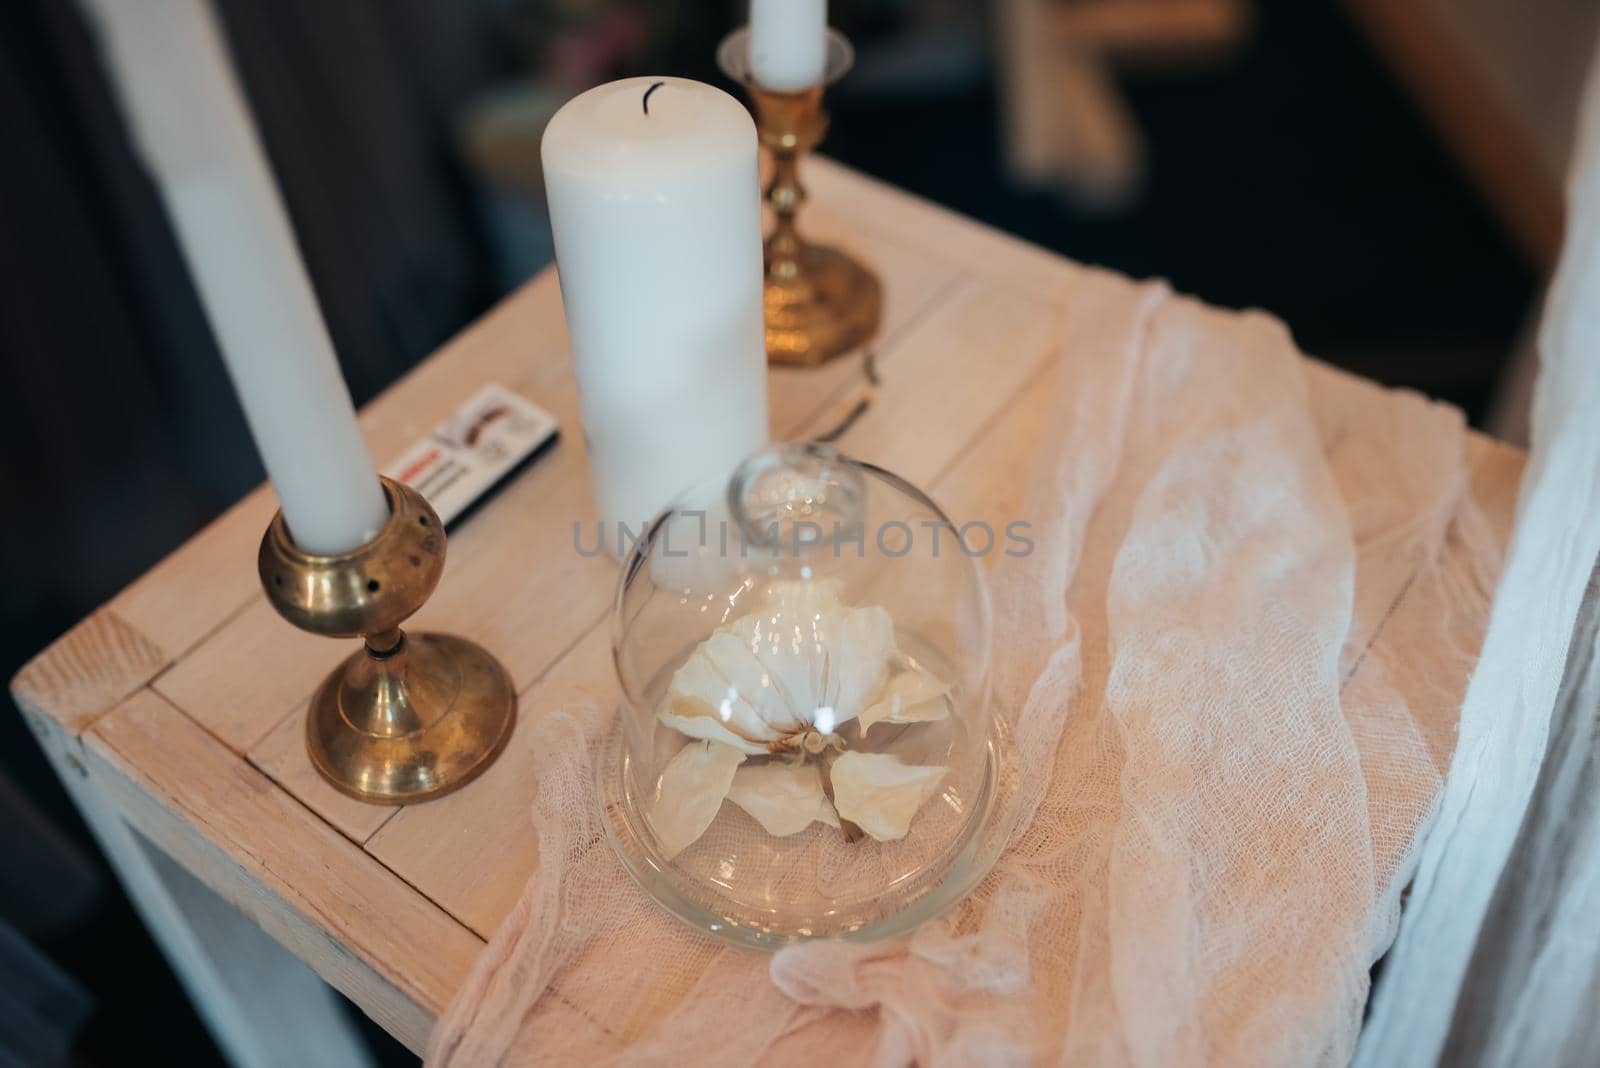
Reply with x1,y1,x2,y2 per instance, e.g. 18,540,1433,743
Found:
650,580,950,859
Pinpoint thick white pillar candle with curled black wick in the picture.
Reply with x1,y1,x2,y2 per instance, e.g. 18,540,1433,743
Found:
542,78,766,529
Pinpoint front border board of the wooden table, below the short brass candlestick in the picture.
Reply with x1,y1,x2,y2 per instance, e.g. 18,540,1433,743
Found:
85,691,483,1050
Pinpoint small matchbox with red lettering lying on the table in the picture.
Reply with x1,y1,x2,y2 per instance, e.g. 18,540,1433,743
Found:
384,384,557,526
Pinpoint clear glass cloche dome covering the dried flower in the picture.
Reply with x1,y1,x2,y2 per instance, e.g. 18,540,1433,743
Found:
600,444,1014,946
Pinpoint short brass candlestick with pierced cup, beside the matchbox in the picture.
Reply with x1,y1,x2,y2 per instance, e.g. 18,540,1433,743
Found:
258,478,517,804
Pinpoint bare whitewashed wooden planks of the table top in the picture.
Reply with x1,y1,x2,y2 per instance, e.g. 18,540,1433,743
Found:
13,160,1523,1050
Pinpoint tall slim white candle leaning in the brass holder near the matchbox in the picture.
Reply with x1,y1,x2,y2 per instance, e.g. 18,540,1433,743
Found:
88,0,389,553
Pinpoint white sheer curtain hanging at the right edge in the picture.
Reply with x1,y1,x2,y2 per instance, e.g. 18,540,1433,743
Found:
1357,27,1600,1068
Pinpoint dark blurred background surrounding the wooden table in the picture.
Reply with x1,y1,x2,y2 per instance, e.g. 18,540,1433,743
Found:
0,0,1592,1065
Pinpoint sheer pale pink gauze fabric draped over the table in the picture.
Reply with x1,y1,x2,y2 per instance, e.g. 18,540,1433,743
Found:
429,270,1498,1068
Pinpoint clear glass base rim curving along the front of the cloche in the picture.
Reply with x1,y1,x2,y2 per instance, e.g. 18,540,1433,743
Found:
597,703,1018,951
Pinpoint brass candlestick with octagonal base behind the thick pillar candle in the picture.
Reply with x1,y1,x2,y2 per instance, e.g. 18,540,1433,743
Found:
717,27,883,365
